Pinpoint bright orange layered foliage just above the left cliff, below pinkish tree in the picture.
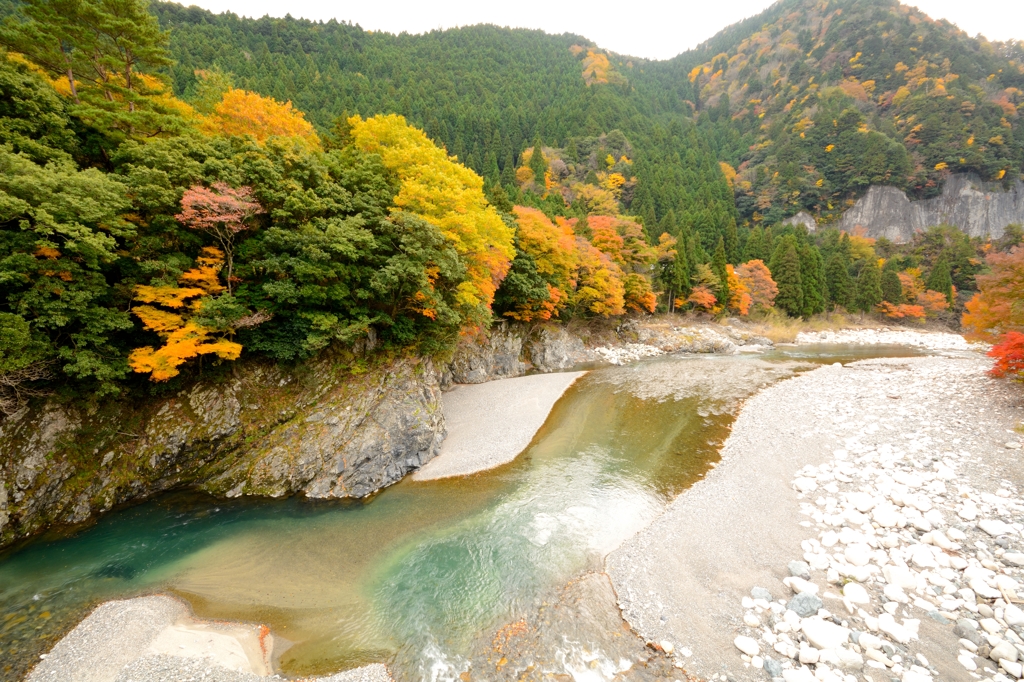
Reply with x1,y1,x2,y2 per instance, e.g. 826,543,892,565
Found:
128,247,242,381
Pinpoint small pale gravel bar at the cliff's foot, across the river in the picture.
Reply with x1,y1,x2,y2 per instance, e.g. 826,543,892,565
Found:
413,372,586,480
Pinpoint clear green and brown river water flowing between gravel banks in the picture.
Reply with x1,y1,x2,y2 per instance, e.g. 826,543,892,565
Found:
0,347,921,680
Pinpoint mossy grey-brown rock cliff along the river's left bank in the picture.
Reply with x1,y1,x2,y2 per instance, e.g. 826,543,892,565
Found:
0,352,444,547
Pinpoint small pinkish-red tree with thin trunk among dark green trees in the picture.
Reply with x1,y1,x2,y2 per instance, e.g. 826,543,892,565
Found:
174,182,263,293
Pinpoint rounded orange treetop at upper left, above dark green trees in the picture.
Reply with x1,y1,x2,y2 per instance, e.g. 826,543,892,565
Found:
202,88,321,148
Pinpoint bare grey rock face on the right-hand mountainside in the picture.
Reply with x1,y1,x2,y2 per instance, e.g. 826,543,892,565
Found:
839,173,1024,243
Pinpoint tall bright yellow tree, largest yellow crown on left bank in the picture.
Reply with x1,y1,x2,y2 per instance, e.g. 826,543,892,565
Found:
348,114,515,321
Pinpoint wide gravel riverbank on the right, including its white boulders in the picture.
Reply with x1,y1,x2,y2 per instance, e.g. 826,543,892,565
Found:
607,355,1024,682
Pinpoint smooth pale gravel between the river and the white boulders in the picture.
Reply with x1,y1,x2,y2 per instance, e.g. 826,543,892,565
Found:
606,356,1020,682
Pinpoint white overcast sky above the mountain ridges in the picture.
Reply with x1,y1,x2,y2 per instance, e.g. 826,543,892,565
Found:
178,0,1024,59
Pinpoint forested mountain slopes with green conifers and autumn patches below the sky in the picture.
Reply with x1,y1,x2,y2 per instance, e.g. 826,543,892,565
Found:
146,0,1024,231
